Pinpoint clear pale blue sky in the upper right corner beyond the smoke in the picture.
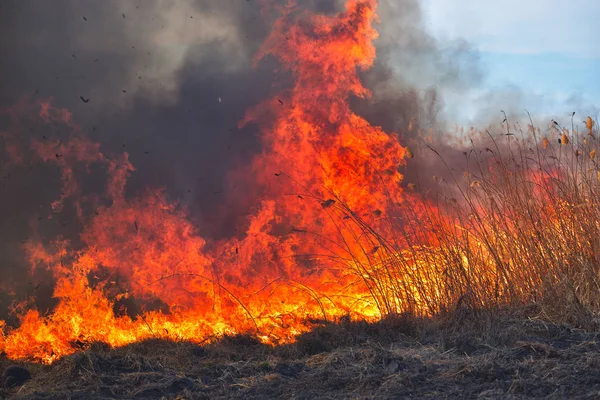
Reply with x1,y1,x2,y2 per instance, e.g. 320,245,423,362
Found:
422,0,600,122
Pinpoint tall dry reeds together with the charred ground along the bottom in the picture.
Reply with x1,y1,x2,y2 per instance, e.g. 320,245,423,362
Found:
0,118,600,399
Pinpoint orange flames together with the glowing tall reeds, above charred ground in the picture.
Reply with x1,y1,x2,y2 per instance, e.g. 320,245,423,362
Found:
0,0,600,386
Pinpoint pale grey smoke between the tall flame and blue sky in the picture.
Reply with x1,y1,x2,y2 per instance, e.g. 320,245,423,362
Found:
346,0,482,191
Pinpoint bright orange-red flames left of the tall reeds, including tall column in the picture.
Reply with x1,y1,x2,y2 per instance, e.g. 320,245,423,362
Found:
0,0,406,363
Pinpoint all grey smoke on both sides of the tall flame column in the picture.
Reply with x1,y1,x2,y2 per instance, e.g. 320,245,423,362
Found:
0,0,496,319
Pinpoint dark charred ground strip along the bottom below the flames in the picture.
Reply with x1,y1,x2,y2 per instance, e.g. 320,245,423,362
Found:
0,312,600,399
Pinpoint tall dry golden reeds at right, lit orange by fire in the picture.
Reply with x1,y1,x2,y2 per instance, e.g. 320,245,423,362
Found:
330,112,600,328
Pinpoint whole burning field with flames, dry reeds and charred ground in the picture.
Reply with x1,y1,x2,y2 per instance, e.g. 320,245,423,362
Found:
0,0,600,399
